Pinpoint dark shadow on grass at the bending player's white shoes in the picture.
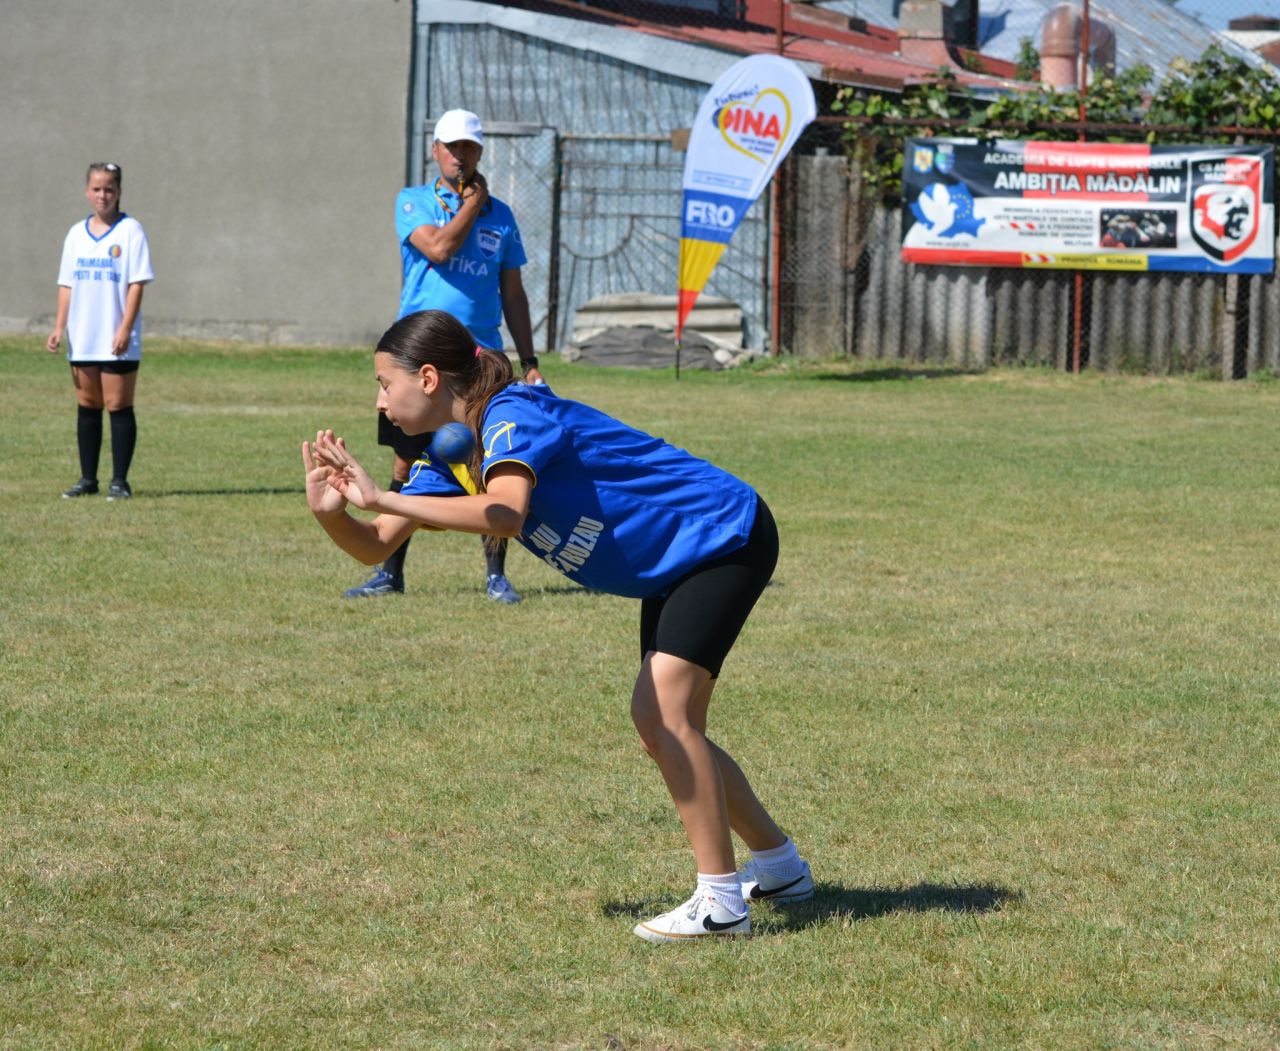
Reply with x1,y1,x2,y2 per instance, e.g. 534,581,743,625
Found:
600,883,1023,933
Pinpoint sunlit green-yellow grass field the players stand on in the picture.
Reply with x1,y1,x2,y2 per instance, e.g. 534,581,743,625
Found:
0,338,1280,1048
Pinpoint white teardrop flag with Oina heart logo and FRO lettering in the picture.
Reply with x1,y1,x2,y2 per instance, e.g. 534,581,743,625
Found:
676,55,818,353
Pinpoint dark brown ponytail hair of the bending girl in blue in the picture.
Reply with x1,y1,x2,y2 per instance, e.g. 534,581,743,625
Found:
378,310,516,493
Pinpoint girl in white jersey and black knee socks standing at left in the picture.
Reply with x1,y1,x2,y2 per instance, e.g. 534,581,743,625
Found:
46,164,155,501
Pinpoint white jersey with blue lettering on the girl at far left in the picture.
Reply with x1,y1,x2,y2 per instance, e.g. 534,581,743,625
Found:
58,213,155,364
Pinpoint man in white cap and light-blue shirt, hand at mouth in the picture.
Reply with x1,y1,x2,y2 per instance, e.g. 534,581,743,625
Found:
346,110,543,603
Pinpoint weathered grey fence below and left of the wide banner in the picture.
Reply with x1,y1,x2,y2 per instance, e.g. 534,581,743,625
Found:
774,123,1280,378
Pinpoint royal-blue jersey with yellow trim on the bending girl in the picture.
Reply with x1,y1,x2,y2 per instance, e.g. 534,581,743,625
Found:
402,383,756,598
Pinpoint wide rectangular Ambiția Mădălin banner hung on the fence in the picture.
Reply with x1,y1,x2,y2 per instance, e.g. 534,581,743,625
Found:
902,138,1276,274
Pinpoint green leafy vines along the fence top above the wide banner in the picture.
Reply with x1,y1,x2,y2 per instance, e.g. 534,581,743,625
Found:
832,41,1280,205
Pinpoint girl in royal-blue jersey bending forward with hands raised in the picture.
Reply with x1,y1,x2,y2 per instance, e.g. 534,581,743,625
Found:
302,310,813,941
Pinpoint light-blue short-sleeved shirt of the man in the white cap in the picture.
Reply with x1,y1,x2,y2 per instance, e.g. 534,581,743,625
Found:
396,179,527,351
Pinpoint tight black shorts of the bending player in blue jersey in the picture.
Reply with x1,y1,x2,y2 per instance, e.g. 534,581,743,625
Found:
640,499,778,678
